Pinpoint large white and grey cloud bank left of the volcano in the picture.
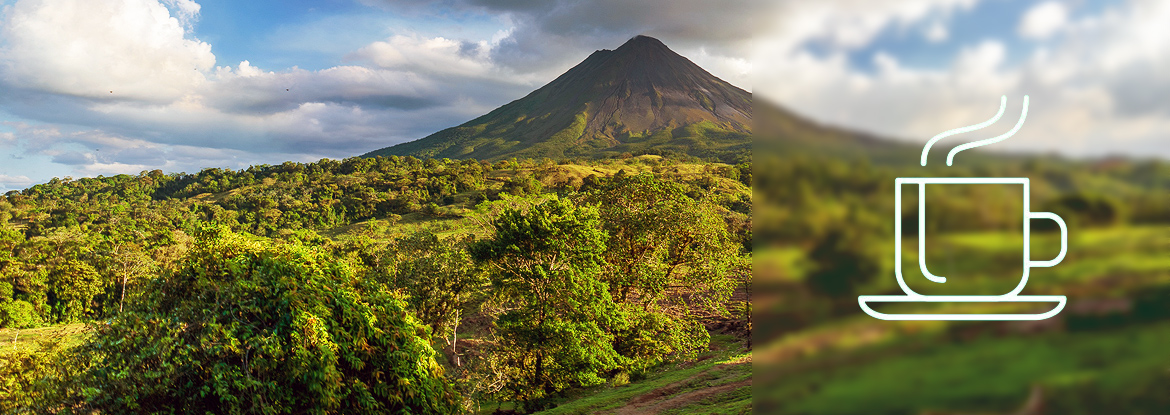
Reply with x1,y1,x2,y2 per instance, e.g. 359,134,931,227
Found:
0,0,531,178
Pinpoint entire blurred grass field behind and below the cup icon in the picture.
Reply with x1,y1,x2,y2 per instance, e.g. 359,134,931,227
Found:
755,226,1170,414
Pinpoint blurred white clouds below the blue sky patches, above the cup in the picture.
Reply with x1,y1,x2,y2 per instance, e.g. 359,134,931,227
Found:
755,0,1170,158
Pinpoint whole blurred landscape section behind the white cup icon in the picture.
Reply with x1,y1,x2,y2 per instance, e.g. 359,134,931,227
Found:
752,0,1170,414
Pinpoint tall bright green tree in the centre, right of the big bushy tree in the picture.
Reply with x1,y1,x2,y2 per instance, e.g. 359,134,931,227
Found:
473,199,622,409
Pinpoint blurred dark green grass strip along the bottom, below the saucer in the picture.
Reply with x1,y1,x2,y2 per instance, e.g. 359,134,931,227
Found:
757,323,1170,414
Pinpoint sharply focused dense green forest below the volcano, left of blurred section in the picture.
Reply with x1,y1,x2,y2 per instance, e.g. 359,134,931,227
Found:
0,155,751,414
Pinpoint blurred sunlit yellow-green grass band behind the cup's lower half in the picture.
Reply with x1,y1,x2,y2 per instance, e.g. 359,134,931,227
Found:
753,226,1170,343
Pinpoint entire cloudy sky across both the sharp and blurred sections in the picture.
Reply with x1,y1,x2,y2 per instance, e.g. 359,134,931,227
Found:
0,0,1170,192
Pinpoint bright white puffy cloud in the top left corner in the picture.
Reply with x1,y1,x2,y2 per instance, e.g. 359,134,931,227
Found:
0,0,215,102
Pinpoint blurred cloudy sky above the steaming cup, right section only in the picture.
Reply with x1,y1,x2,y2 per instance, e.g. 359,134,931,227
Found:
752,0,1170,159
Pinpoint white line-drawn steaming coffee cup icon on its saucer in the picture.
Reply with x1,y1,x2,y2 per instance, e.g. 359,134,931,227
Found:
858,96,1068,320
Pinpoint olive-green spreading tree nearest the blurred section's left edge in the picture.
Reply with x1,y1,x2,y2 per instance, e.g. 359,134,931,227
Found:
584,174,750,367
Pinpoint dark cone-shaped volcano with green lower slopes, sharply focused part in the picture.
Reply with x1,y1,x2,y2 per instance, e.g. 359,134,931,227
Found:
363,36,752,161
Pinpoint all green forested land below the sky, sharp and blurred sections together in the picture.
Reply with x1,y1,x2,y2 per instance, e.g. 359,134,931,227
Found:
0,143,1170,414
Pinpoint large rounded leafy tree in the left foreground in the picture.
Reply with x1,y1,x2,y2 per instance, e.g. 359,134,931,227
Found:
70,228,457,414
